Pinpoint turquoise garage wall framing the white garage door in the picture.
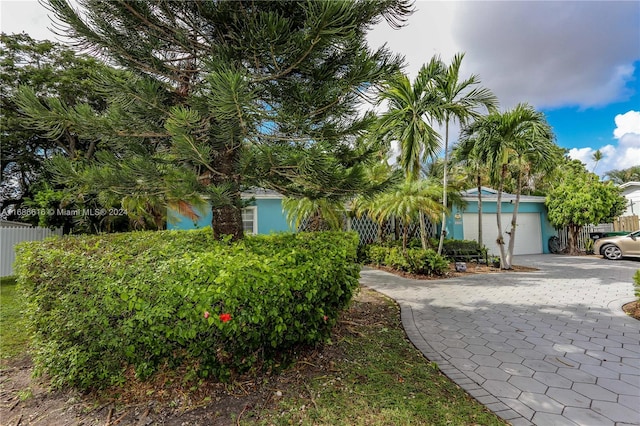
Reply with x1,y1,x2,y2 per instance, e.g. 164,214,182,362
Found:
446,201,557,254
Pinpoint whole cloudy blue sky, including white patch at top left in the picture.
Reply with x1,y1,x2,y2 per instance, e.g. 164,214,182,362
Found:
0,0,640,175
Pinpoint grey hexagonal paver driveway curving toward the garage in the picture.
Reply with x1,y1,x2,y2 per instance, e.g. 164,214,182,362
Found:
360,255,640,426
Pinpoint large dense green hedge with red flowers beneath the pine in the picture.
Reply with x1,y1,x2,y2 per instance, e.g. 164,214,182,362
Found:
16,230,359,388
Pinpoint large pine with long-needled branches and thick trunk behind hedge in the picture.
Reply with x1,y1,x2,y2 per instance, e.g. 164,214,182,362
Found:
25,0,410,239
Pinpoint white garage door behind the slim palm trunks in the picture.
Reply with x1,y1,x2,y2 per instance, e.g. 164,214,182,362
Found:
462,213,542,256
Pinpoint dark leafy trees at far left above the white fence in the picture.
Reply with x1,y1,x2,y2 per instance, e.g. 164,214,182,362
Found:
0,33,128,232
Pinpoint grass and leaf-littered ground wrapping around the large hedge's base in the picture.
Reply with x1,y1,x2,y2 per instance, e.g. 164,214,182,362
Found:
0,279,507,426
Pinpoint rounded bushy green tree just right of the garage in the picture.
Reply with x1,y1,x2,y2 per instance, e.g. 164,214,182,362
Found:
546,160,626,255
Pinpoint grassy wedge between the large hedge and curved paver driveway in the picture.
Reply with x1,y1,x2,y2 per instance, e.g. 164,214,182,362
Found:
244,289,507,426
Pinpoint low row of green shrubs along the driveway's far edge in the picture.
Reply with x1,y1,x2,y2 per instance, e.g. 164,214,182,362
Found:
360,244,449,275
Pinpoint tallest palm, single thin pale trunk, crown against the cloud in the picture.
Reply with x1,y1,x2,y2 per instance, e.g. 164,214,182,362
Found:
427,53,498,254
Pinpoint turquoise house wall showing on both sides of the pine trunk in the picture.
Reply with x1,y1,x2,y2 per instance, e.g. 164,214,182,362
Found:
167,199,291,234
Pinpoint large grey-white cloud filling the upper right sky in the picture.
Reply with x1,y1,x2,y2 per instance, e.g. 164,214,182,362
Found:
368,1,640,108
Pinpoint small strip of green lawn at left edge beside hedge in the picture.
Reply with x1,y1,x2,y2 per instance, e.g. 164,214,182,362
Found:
0,277,28,360
